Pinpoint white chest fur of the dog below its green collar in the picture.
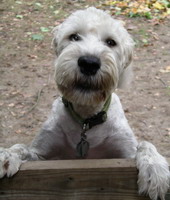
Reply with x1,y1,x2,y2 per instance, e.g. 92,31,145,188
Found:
41,94,137,159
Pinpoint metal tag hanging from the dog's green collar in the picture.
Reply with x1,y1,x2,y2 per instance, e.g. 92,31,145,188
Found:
76,138,89,158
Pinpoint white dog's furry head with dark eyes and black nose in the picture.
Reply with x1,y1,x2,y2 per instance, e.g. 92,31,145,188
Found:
54,8,133,105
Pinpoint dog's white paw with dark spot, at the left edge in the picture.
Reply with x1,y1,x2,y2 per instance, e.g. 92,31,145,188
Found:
0,148,21,178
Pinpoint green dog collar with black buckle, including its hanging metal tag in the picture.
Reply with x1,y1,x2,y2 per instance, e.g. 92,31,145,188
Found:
62,96,111,158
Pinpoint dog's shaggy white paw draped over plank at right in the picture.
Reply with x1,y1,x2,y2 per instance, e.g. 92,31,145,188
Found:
136,142,170,200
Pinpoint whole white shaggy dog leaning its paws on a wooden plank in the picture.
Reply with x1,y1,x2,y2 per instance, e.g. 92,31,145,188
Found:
0,8,170,200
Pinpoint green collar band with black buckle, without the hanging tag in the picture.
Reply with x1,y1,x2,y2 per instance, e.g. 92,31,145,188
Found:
62,96,111,130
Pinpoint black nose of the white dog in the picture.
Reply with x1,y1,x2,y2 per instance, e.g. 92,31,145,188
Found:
78,56,101,76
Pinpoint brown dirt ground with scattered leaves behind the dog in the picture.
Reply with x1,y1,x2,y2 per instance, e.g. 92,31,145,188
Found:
0,0,170,157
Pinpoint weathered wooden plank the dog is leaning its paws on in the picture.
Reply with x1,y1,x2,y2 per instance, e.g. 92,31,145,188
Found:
0,159,170,200
